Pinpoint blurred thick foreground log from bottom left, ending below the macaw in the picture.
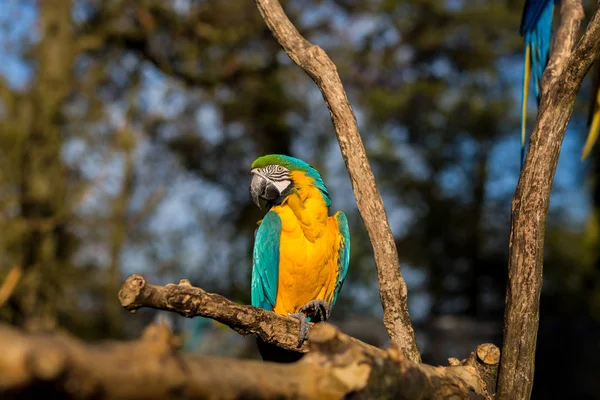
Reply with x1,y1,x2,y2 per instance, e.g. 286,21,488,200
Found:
0,325,370,400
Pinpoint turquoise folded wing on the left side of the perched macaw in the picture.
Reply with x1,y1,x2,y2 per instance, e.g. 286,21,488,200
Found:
251,211,281,310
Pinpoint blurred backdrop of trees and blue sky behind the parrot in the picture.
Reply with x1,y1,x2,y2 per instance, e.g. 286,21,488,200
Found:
0,0,600,398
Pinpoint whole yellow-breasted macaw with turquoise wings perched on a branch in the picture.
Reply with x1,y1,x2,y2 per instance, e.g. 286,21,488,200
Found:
250,154,350,347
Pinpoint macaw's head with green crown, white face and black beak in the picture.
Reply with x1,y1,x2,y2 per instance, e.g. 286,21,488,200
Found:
250,154,331,209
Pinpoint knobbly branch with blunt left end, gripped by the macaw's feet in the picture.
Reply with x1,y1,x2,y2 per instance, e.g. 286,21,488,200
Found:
119,275,384,356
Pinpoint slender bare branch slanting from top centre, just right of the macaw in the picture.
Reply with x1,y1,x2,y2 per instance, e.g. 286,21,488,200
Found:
256,0,421,361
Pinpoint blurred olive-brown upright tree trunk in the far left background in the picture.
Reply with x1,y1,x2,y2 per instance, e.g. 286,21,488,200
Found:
19,0,73,330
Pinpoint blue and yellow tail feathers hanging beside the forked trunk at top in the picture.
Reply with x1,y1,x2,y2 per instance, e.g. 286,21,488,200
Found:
520,0,554,168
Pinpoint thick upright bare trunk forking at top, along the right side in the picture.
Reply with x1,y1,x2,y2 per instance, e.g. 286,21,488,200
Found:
498,0,600,400
